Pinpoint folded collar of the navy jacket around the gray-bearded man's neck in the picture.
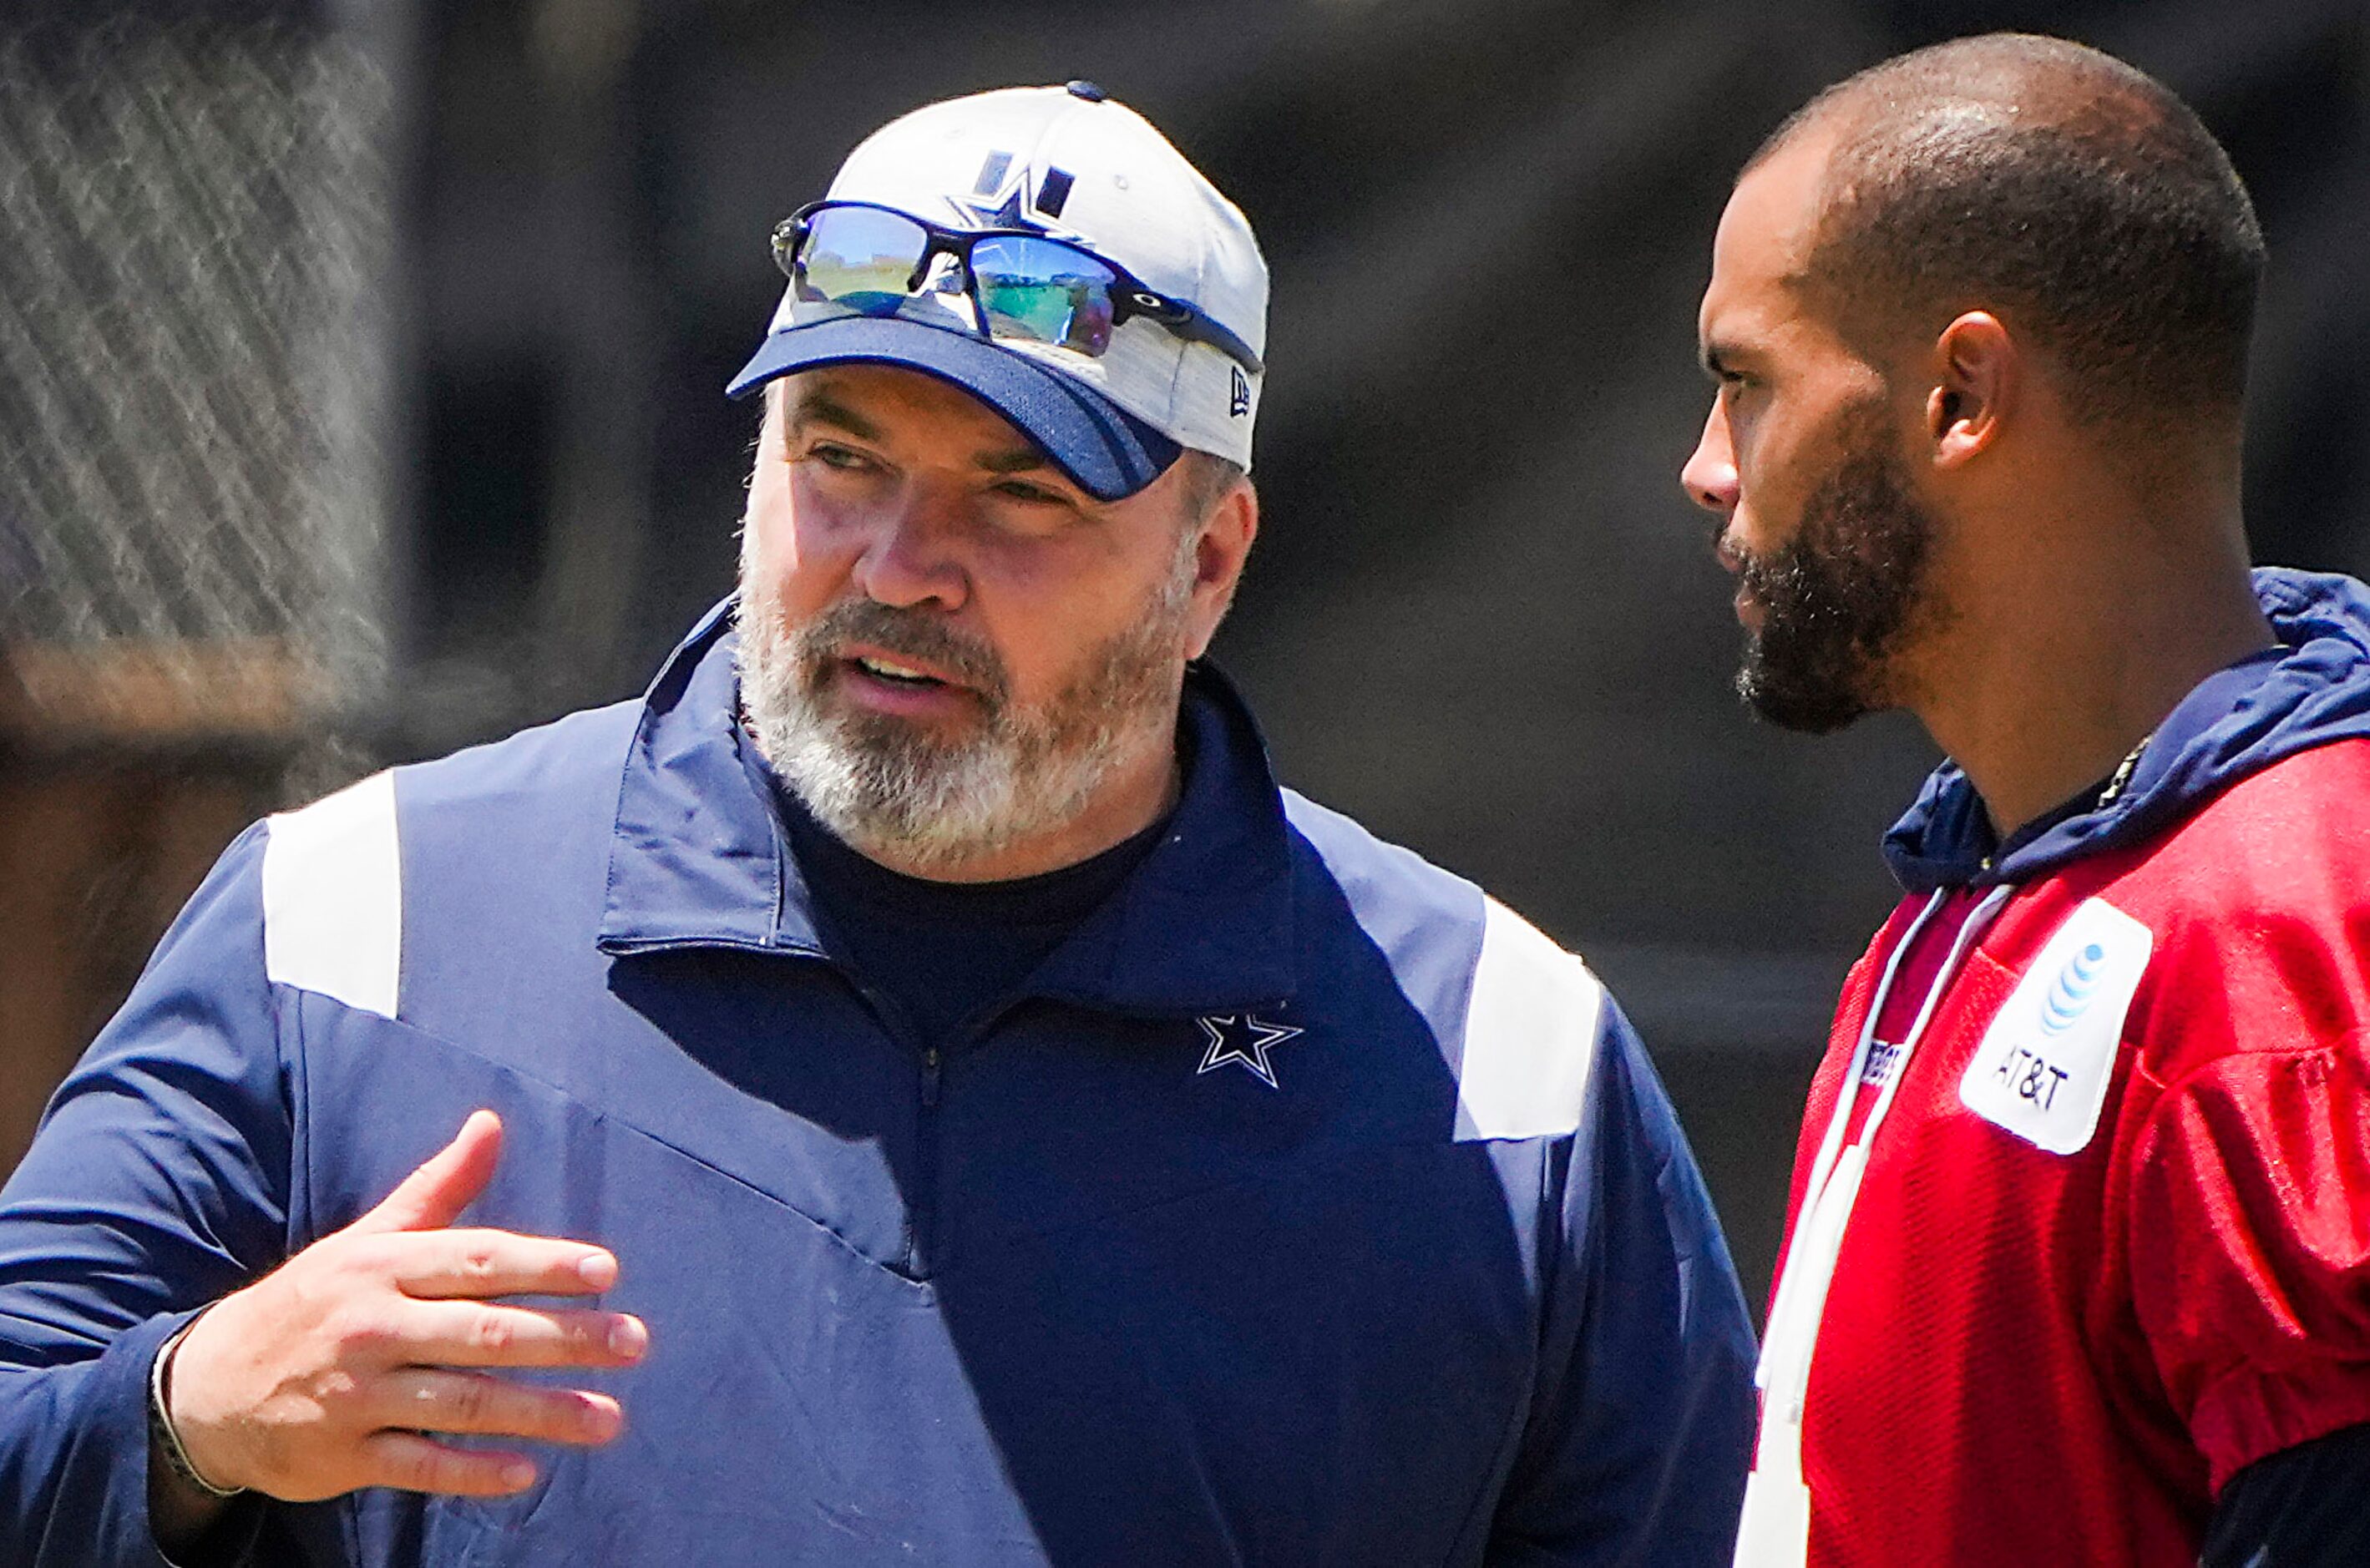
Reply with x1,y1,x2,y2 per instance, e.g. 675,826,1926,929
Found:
600,599,1296,1014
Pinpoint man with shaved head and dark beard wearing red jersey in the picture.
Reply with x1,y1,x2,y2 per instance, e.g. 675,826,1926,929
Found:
1683,36,2370,1568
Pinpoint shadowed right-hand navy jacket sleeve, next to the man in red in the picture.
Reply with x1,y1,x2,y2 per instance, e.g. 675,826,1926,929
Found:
1488,997,1754,1568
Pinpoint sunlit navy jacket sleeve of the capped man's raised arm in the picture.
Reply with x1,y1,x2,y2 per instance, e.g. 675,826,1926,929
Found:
0,824,291,1568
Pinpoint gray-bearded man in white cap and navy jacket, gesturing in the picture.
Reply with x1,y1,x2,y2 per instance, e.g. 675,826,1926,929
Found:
0,83,1751,1568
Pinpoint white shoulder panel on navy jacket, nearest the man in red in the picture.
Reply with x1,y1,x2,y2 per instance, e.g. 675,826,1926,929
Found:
1457,895,1604,1141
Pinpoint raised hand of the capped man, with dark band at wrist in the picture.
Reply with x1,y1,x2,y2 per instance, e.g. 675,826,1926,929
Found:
152,1110,650,1542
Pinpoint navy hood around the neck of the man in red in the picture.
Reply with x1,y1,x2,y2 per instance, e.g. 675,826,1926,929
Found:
1884,566,2370,893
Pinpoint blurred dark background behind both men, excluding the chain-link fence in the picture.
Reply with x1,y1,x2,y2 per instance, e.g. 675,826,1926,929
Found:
13,0,2370,1305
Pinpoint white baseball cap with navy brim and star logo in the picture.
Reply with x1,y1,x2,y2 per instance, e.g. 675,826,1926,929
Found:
727,80,1268,500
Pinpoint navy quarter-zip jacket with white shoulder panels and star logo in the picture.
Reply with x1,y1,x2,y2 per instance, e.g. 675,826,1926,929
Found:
0,611,1751,1568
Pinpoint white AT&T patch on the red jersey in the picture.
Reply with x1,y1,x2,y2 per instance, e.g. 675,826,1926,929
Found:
1957,898,2157,1154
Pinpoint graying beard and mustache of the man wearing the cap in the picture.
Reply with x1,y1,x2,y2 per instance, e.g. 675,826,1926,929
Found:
739,529,1199,874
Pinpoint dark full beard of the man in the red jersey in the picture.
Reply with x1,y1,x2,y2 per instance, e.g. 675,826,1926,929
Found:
1737,405,1941,734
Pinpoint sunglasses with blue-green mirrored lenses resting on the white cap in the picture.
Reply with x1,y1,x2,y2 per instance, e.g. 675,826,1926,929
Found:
772,201,1261,378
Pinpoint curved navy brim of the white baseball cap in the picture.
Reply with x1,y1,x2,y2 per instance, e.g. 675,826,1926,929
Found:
725,315,1182,500
